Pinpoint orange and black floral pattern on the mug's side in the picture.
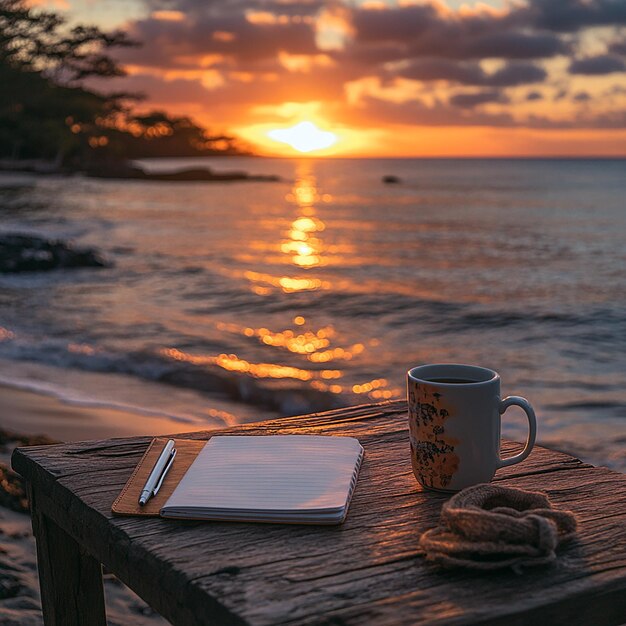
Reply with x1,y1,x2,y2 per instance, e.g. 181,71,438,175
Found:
409,384,459,489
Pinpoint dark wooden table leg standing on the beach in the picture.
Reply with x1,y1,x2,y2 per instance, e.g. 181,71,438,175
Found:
30,490,106,626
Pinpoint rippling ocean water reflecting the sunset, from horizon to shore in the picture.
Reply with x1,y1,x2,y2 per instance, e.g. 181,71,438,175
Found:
0,158,626,469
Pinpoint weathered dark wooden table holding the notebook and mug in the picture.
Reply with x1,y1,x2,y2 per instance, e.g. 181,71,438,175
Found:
13,402,626,626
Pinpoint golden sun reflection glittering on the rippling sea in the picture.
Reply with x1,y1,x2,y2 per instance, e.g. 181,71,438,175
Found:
202,162,402,400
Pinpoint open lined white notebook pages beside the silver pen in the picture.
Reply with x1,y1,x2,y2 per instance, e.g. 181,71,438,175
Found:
161,435,363,524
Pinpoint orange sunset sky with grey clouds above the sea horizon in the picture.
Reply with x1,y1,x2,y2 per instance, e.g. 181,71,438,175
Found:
41,0,626,156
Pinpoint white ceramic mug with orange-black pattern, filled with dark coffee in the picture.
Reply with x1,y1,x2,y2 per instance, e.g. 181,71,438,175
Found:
407,363,537,491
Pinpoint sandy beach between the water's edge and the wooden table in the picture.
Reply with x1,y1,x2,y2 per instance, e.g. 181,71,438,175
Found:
0,386,218,626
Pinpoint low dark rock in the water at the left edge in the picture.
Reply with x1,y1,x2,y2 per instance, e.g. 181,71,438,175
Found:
0,234,108,273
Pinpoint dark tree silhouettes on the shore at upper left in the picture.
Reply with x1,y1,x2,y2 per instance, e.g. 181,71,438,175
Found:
0,0,249,166
